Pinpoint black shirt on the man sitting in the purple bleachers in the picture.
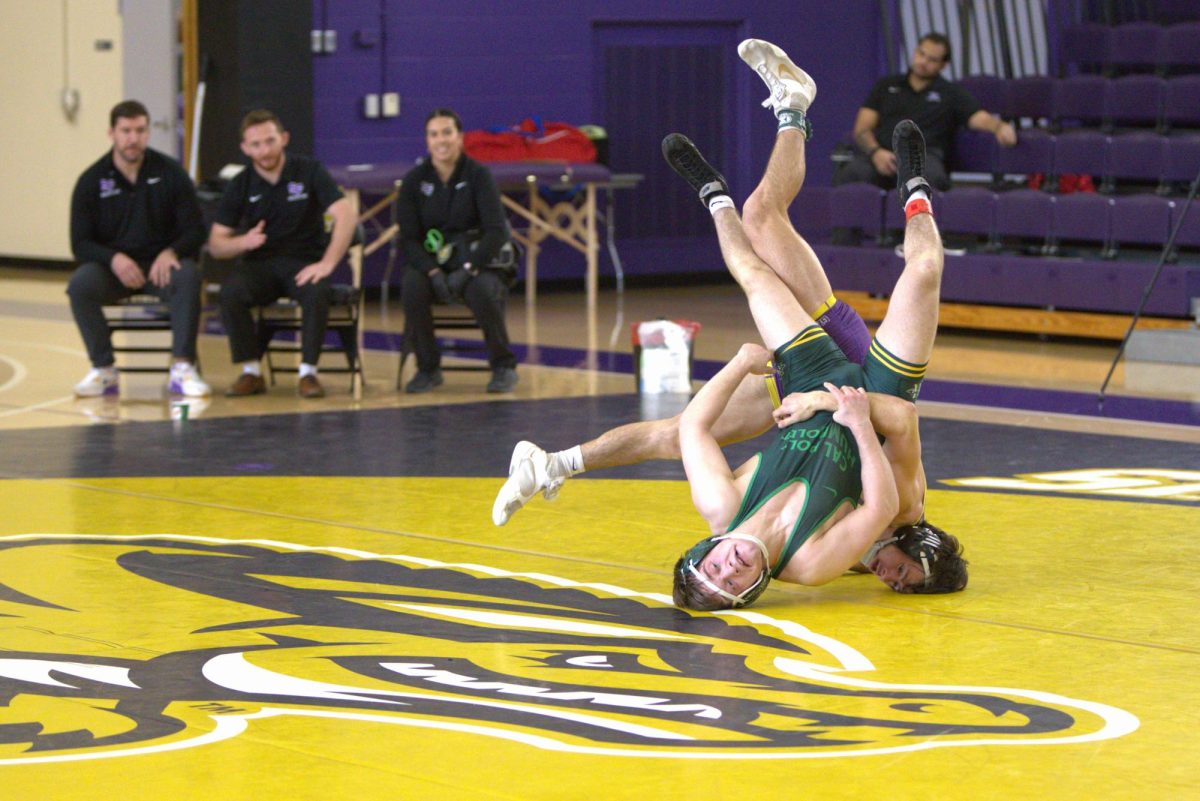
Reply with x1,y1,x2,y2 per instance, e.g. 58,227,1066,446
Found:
863,74,980,153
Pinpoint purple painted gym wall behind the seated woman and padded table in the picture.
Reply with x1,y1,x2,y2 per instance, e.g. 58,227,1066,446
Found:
313,0,882,287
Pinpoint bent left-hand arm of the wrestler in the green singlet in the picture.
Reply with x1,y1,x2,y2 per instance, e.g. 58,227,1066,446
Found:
679,344,769,532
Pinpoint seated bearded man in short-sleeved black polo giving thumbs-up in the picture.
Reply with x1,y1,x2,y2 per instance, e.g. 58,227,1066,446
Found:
209,110,356,398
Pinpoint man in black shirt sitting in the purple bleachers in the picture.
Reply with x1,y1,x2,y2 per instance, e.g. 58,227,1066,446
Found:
833,34,1016,191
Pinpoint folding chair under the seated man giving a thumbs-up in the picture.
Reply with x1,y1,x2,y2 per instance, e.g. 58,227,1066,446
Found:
257,224,366,401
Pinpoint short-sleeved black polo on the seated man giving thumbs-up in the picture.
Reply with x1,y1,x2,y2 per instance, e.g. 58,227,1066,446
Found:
216,153,342,264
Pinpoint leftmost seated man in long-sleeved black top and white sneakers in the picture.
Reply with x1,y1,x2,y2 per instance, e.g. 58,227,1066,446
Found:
67,101,209,398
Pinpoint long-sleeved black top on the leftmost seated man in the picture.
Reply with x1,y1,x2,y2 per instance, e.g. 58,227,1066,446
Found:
71,149,205,265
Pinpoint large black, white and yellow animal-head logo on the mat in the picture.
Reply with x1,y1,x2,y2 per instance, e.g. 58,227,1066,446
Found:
0,535,1138,765
